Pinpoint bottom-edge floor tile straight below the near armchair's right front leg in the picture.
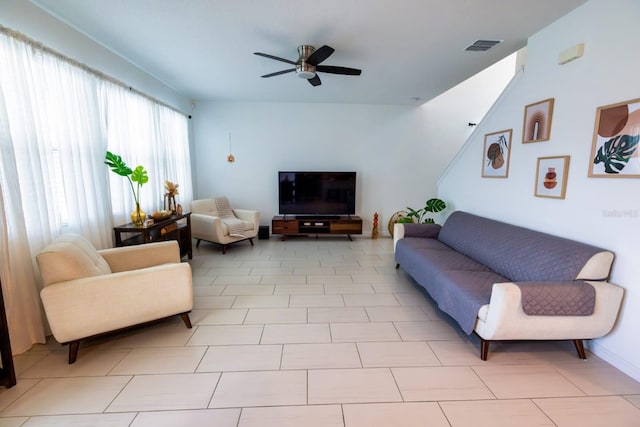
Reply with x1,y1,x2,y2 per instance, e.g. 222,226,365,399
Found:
131,408,240,427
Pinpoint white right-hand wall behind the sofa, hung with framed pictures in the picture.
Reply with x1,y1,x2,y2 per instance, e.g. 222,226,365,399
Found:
438,0,640,380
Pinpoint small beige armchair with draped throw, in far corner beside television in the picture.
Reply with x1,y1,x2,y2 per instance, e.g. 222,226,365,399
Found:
191,197,260,254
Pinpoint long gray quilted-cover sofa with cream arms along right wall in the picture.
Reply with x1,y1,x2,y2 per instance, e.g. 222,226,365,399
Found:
394,211,623,360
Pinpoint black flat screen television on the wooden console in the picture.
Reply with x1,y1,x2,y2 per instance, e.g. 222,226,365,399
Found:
278,171,356,216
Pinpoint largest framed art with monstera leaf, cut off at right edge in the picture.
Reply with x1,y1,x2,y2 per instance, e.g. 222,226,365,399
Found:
589,98,640,178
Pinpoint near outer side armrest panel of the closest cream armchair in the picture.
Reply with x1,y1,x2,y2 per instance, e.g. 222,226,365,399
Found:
40,263,193,343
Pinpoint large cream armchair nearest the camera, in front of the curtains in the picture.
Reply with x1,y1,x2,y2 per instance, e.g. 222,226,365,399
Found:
36,234,193,363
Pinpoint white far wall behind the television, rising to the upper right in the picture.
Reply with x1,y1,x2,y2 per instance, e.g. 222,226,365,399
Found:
193,56,515,234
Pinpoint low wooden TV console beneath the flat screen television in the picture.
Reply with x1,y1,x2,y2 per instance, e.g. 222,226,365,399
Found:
271,215,362,240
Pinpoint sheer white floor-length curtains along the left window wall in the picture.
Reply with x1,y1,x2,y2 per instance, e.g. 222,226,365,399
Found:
0,26,192,353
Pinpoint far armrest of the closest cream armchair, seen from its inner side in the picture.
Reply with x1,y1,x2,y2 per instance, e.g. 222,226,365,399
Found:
98,240,180,273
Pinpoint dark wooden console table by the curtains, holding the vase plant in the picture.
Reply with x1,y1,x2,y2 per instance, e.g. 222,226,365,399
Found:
113,212,193,259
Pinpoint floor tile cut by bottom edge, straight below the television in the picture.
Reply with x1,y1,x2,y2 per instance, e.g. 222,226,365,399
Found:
238,405,344,427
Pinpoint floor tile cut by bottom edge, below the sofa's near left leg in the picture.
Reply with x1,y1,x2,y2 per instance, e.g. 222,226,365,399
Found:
440,400,555,427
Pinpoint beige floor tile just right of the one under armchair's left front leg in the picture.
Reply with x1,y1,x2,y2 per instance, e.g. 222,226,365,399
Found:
109,347,206,375
